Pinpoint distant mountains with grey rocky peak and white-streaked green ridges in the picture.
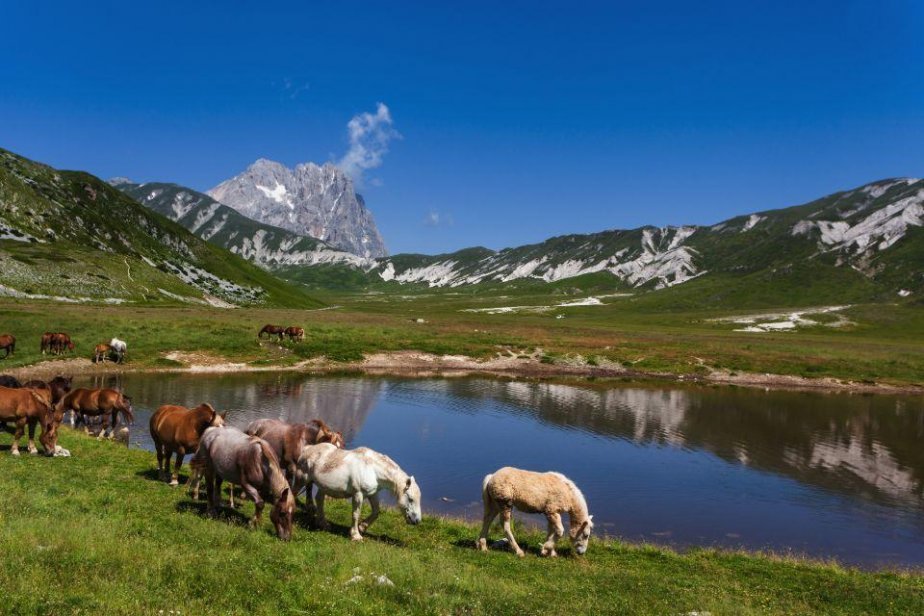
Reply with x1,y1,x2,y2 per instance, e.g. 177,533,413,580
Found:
110,168,924,305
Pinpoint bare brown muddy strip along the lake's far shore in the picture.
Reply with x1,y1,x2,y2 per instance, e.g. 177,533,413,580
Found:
9,351,924,395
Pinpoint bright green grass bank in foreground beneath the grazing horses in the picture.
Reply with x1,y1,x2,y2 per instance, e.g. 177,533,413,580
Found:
0,430,924,614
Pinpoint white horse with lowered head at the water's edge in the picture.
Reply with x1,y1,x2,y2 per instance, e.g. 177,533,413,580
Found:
292,443,421,541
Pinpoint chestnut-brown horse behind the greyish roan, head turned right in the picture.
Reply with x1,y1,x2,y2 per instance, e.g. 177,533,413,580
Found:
149,404,225,486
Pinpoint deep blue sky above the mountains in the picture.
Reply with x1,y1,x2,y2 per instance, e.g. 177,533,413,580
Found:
0,0,924,253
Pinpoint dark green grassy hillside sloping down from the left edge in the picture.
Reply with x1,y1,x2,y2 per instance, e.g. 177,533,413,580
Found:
0,149,320,307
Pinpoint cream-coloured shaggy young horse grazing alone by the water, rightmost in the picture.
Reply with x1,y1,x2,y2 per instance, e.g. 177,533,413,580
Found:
478,466,594,558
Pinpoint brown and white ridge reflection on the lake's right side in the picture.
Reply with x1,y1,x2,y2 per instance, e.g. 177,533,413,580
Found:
434,380,924,507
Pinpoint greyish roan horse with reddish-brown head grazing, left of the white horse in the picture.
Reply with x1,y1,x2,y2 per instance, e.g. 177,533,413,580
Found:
191,427,295,541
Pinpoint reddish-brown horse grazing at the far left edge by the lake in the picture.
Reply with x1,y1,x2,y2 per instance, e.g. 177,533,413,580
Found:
0,387,61,456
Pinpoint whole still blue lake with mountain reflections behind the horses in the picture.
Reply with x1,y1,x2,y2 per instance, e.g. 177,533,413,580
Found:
81,373,924,567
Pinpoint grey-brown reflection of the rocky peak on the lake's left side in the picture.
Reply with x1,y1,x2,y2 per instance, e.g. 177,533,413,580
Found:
104,373,384,440
